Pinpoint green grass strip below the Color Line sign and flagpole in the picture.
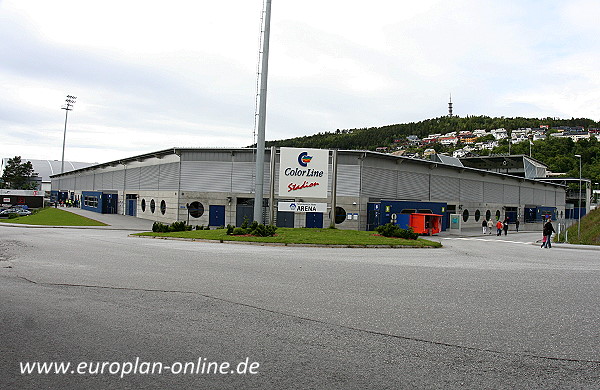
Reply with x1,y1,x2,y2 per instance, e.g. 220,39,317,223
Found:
136,228,442,248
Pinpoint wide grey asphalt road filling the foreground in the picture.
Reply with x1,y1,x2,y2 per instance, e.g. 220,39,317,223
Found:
0,226,600,389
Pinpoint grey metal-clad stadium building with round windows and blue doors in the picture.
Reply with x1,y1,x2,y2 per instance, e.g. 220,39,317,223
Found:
52,148,565,230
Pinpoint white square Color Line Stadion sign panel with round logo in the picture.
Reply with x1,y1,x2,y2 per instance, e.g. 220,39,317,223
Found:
279,148,329,199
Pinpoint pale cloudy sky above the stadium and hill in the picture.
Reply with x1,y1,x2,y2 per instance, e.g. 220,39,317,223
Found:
0,0,600,162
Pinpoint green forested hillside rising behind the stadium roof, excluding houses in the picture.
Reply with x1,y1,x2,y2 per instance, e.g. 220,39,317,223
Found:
267,116,600,183
